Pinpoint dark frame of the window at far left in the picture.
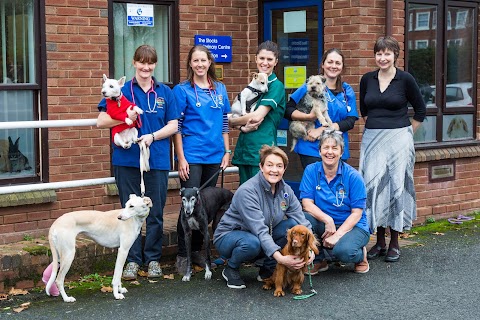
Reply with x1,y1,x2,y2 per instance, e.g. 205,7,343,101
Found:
0,0,49,186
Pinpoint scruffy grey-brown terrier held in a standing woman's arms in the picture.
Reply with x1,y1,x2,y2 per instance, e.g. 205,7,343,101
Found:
289,75,332,151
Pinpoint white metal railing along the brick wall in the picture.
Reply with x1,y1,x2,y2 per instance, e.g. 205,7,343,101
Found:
0,119,238,194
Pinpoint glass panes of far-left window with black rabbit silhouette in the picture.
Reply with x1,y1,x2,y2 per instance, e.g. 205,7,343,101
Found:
0,0,41,184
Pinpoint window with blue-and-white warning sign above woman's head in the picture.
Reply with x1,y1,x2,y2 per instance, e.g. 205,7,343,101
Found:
111,1,179,83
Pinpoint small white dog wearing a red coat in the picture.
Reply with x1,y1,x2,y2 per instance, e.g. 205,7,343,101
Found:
102,74,143,149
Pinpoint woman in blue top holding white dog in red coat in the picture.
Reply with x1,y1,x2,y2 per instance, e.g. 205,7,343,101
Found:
97,45,180,280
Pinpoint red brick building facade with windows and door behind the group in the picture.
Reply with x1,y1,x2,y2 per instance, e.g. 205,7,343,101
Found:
0,0,480,244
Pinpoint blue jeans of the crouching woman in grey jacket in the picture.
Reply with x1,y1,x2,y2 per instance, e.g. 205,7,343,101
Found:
214,219,298,271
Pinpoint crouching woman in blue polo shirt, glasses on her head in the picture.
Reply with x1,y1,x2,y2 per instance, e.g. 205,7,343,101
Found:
300,130,370,274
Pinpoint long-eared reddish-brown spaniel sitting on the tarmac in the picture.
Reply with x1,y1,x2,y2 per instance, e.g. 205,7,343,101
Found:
263,225,319,297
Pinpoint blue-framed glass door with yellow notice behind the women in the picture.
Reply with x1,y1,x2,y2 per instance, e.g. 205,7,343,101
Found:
263,0,323,195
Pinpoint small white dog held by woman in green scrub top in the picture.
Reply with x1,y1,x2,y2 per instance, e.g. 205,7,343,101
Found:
232,72,268,118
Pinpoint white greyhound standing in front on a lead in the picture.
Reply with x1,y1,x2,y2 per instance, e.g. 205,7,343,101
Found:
45,194,152,302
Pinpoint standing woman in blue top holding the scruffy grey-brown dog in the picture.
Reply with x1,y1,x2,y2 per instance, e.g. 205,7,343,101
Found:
285,48,358,169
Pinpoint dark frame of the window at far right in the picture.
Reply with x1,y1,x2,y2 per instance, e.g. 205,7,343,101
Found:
405,0,480,150
